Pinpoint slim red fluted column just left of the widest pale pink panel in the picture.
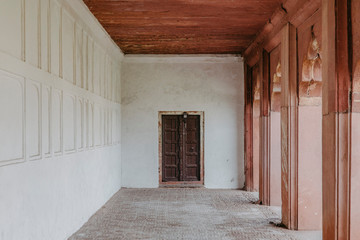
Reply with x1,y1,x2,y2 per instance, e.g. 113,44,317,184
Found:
281,23,298,229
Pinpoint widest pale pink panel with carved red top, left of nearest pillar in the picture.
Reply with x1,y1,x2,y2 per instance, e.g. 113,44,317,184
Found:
297,11,322,230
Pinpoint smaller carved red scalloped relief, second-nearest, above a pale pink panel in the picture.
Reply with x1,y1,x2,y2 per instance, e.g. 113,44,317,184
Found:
270,45,281,112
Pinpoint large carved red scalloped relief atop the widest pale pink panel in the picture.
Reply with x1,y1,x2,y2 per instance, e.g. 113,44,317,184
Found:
298,12,322,105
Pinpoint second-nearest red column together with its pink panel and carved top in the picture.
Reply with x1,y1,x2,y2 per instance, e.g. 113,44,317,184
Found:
260,45,281,206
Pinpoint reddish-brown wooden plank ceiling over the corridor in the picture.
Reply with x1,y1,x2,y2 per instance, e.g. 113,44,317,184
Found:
84,0,283,54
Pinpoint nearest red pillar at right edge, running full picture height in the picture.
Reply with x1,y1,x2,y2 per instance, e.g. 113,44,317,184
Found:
322,0,360,237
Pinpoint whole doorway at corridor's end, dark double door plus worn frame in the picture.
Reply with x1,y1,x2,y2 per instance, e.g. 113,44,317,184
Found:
159,112,203,185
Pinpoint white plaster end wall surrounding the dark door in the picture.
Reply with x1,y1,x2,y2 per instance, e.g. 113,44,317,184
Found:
121,55,245,188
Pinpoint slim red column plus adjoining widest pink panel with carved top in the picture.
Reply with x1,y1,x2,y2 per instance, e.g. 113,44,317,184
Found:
281,12,322,230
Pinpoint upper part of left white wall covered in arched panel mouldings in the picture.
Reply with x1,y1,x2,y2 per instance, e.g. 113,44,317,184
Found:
0,0,123,166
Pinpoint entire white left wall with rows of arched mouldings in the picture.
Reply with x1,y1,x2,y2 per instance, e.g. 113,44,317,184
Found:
0,0,123,240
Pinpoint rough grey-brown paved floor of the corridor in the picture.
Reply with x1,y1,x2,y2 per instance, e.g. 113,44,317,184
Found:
69,188,321,240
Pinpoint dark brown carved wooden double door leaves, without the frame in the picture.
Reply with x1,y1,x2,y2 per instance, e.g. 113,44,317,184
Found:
162,115,200,182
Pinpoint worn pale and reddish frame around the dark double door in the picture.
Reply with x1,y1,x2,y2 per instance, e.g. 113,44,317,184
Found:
158,111,205,186
